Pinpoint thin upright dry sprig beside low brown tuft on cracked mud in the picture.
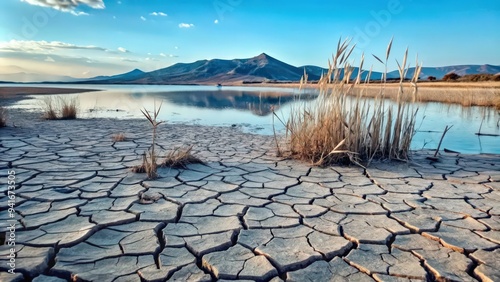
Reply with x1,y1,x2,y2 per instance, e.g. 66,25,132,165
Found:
132,102,163,179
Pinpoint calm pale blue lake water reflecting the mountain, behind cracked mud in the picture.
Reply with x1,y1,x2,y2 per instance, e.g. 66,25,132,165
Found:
5,84,500,154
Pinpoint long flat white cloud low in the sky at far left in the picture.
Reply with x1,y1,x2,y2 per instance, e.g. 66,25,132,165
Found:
0,40,108,53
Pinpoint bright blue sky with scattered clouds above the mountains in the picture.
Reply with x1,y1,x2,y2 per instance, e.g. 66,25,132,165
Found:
0,0,500,77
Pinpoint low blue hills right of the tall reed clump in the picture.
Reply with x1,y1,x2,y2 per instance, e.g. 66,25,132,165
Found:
387,65,500,79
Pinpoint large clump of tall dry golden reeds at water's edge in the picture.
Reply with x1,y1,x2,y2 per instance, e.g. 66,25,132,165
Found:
285,37,421,166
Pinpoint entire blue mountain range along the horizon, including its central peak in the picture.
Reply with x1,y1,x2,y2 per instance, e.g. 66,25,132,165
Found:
0,53,500,84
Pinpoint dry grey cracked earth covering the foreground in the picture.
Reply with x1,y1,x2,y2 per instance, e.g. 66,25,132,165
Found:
0,113,500,282
